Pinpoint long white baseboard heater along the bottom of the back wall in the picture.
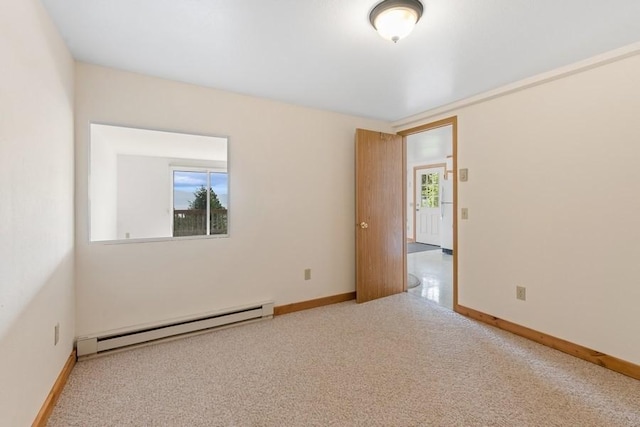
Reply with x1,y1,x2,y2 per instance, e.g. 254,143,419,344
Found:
76,302,273,357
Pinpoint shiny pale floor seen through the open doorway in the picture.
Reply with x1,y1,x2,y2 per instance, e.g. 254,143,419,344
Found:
407,250,453,310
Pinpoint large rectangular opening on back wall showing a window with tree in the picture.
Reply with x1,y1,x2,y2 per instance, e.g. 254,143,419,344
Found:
89,124,229,242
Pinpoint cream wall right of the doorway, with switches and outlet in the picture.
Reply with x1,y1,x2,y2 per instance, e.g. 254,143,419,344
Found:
398,50,640,364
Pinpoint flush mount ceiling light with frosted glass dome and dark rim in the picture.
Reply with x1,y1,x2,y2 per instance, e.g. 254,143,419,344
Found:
369,0,423,43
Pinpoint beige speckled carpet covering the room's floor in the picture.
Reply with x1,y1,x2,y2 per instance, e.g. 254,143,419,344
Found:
49,294,640,427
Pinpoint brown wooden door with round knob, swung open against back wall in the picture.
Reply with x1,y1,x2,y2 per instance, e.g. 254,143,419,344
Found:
356,129,406,302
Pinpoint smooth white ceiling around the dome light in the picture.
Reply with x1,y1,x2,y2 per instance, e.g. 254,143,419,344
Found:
41,0,640,121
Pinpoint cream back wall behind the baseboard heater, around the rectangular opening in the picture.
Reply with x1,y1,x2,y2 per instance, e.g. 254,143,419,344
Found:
76,64,390,335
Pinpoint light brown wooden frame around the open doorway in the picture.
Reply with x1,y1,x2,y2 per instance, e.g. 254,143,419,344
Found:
397,116,460,313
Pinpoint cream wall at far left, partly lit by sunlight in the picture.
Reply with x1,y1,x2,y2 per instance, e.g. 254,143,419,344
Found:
0,0,75,426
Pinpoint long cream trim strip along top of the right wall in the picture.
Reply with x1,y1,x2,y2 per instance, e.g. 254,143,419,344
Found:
391,42,640,132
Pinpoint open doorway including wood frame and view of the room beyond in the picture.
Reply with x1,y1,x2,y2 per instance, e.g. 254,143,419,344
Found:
400,117,457,310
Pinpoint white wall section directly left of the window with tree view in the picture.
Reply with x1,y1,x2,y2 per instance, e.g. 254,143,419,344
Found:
117,154,172,239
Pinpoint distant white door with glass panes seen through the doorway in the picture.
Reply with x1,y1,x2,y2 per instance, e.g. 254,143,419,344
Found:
414,167,444,246
